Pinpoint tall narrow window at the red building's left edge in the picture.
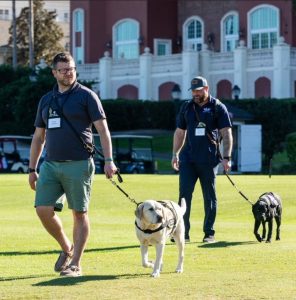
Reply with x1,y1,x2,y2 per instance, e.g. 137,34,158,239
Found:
73,9,84,64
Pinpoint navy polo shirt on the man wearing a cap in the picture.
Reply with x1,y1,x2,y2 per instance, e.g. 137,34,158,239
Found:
177,96,232,166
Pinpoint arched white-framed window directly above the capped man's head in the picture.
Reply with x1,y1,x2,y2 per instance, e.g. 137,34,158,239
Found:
183,17,204,51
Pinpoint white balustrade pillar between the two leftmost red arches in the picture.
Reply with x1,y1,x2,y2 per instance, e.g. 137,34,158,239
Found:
139,47,155,100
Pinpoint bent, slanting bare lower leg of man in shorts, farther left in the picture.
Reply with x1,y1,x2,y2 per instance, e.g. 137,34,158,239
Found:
36,206,72,252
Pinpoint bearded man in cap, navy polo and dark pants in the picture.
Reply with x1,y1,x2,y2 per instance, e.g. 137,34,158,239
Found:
172,76,233,243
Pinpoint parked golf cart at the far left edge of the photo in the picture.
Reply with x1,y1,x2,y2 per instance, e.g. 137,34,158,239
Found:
0,135,32,173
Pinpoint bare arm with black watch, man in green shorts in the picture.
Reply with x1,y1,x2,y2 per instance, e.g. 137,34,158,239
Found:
29,127,45,190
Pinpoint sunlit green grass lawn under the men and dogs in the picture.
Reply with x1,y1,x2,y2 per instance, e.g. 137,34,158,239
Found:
0,175,296,300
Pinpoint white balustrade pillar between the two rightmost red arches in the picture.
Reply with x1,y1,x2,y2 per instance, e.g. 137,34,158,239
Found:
232,40,247,99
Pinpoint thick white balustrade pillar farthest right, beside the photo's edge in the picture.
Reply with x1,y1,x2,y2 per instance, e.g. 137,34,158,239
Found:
271,37,292,99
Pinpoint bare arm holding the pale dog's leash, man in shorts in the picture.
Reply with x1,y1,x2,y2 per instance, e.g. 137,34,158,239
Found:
94,119,117,178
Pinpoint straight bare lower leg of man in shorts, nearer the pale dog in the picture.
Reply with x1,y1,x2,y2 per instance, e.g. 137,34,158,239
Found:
71,210,90,268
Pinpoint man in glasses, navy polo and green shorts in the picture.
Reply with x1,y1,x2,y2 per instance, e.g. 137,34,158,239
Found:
29,53,117,277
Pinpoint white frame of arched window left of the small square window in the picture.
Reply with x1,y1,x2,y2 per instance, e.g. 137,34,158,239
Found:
112,18,140,60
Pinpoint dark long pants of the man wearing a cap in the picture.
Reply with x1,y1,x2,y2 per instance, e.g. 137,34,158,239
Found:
179,162,218,238
